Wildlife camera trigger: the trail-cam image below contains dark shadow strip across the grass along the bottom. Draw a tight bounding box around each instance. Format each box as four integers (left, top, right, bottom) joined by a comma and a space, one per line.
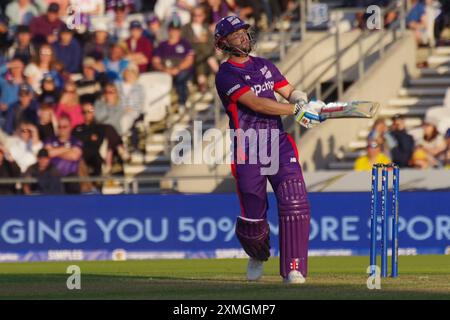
0, 274, 450, 300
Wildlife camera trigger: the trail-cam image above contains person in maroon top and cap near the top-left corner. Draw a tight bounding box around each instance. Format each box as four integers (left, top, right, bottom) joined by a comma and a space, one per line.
30, 2, 64, 44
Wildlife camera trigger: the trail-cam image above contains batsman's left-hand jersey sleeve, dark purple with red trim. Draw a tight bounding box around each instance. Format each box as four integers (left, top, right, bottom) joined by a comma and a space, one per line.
216, 69, 250, 103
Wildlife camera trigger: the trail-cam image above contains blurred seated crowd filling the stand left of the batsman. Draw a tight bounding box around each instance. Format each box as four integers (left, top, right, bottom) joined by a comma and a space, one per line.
0, 0, 294, 193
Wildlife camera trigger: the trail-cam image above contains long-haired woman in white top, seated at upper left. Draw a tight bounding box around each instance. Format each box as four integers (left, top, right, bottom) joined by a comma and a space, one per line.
24, 44, 62, 94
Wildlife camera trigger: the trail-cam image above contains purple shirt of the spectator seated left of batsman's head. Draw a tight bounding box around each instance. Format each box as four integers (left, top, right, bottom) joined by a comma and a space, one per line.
153, 39, 194, 68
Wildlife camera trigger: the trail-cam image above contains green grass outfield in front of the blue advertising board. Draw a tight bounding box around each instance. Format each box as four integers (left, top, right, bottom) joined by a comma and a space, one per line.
0, 255, 450, 299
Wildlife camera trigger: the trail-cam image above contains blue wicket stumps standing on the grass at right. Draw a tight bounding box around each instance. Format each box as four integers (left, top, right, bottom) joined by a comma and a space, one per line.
369, 163, 400, 278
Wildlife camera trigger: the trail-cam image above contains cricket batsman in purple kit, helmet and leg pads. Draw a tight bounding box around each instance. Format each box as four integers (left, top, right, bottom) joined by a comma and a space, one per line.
214, 16, 324, 284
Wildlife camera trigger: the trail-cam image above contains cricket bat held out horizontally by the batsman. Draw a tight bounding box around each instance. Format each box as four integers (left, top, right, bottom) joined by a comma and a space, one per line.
320, 101, 380, 121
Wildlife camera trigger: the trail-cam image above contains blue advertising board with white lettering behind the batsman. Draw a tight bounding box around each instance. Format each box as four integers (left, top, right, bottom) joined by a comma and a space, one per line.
0, 192, 450, 261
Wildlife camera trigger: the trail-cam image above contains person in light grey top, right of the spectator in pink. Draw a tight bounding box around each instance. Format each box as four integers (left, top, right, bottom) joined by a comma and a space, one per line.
95, 83, 126, 136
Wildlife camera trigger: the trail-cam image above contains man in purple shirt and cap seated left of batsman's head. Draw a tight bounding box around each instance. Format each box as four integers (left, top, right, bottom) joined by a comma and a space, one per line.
152, 19, 194, 113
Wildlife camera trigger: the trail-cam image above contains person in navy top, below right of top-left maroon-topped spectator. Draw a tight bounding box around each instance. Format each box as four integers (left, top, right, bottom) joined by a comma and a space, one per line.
53, 25, 82, 73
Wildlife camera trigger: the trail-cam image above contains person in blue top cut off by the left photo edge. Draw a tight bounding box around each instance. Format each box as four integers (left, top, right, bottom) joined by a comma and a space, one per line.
0, 58, 25, 127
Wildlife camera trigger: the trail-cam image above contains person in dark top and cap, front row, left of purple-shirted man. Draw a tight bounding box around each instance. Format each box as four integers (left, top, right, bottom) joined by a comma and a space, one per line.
23, 149, 64, 194
